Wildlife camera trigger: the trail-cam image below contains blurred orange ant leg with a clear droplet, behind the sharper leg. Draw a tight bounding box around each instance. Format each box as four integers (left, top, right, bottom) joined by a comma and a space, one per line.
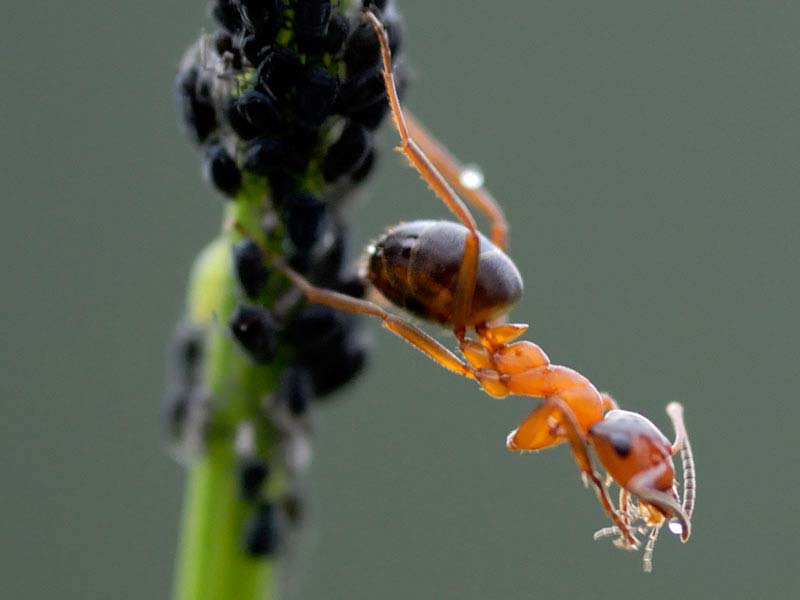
405, 109, 508, 250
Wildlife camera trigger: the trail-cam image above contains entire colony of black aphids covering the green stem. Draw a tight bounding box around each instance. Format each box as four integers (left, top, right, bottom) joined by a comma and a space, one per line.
165, 0, 403, 555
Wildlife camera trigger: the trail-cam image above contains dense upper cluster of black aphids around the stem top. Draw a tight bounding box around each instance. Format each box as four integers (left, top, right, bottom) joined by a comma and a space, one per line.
177, 0, 405, 201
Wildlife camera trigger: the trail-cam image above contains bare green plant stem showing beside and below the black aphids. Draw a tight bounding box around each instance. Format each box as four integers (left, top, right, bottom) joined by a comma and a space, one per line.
173, 187, 285, 600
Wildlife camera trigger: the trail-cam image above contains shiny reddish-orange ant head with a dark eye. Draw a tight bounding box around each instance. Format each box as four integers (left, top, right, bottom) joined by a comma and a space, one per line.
589, 409, 674, 492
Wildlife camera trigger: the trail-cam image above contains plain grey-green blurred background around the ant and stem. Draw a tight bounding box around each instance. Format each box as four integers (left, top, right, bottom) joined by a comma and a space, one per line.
0, 0, 800, 600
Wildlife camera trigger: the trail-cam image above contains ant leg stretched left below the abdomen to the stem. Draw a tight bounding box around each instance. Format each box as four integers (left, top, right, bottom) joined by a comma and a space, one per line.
272, 258, 475, 379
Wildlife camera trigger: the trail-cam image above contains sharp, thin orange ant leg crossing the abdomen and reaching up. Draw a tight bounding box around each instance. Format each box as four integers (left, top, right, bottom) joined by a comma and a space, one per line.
364, 10, 480, 340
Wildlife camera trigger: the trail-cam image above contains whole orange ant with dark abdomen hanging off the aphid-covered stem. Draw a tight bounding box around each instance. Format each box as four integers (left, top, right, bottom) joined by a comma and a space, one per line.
236, 10, 695, 571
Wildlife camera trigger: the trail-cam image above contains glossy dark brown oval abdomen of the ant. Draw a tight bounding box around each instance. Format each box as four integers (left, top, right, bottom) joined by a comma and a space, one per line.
366, 221, 522, 327
